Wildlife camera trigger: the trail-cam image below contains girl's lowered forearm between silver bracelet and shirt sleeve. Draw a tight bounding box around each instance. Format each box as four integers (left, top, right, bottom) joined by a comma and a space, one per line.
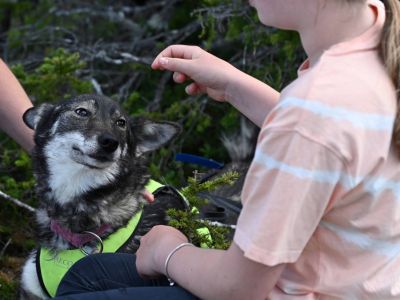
168, 243, 284, 300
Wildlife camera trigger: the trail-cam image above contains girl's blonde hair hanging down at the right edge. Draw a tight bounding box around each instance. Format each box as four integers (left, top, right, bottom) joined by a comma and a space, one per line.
380, 0, 400, 155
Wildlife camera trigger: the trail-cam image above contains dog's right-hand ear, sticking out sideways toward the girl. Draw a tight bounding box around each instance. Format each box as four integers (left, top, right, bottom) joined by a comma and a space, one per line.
132, 120, 181, 155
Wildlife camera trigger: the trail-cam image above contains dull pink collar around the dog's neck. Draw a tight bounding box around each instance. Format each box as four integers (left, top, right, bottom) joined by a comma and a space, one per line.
50, 220, 110, 248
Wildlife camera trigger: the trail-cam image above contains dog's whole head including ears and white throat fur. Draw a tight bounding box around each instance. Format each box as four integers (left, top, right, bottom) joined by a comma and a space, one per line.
23, 95, 180, 203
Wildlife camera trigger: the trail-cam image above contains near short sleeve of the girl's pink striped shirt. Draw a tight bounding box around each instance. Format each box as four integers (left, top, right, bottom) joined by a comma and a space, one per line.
234, 128, 345, 266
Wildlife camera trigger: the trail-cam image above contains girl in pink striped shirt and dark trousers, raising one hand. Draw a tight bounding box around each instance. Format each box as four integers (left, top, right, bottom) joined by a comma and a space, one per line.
54, 0, 400, 300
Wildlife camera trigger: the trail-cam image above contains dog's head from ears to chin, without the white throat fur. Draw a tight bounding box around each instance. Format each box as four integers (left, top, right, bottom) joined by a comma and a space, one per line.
23, 95, 180, 165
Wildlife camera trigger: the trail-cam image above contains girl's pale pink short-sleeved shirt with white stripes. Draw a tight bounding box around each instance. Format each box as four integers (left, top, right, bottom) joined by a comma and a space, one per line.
234, 0, 400, 300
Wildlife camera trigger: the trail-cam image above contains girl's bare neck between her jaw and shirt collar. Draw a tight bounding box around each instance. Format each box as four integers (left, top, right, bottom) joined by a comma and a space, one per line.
298, 1, 376, 66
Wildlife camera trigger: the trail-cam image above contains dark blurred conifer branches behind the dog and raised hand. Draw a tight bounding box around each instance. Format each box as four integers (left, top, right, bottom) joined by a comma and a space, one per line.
0, 0, 304, 299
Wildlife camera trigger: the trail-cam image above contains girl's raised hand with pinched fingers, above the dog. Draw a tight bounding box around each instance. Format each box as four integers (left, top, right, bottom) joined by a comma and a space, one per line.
151, 45, 238, 101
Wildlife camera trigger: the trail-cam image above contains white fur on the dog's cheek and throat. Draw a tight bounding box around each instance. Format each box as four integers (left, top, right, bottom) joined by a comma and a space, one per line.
44, 132, 121, 204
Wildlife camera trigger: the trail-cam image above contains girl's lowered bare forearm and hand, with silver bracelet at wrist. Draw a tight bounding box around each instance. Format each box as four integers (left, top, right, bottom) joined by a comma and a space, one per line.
136, 226, 285, 300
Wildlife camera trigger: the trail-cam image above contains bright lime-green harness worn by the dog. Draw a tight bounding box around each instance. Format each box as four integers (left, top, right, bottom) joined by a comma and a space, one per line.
36, 180, 163, 297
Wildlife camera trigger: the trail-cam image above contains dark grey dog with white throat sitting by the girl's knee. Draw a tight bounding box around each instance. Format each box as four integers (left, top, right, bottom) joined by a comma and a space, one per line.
21, 95, 186, 299
